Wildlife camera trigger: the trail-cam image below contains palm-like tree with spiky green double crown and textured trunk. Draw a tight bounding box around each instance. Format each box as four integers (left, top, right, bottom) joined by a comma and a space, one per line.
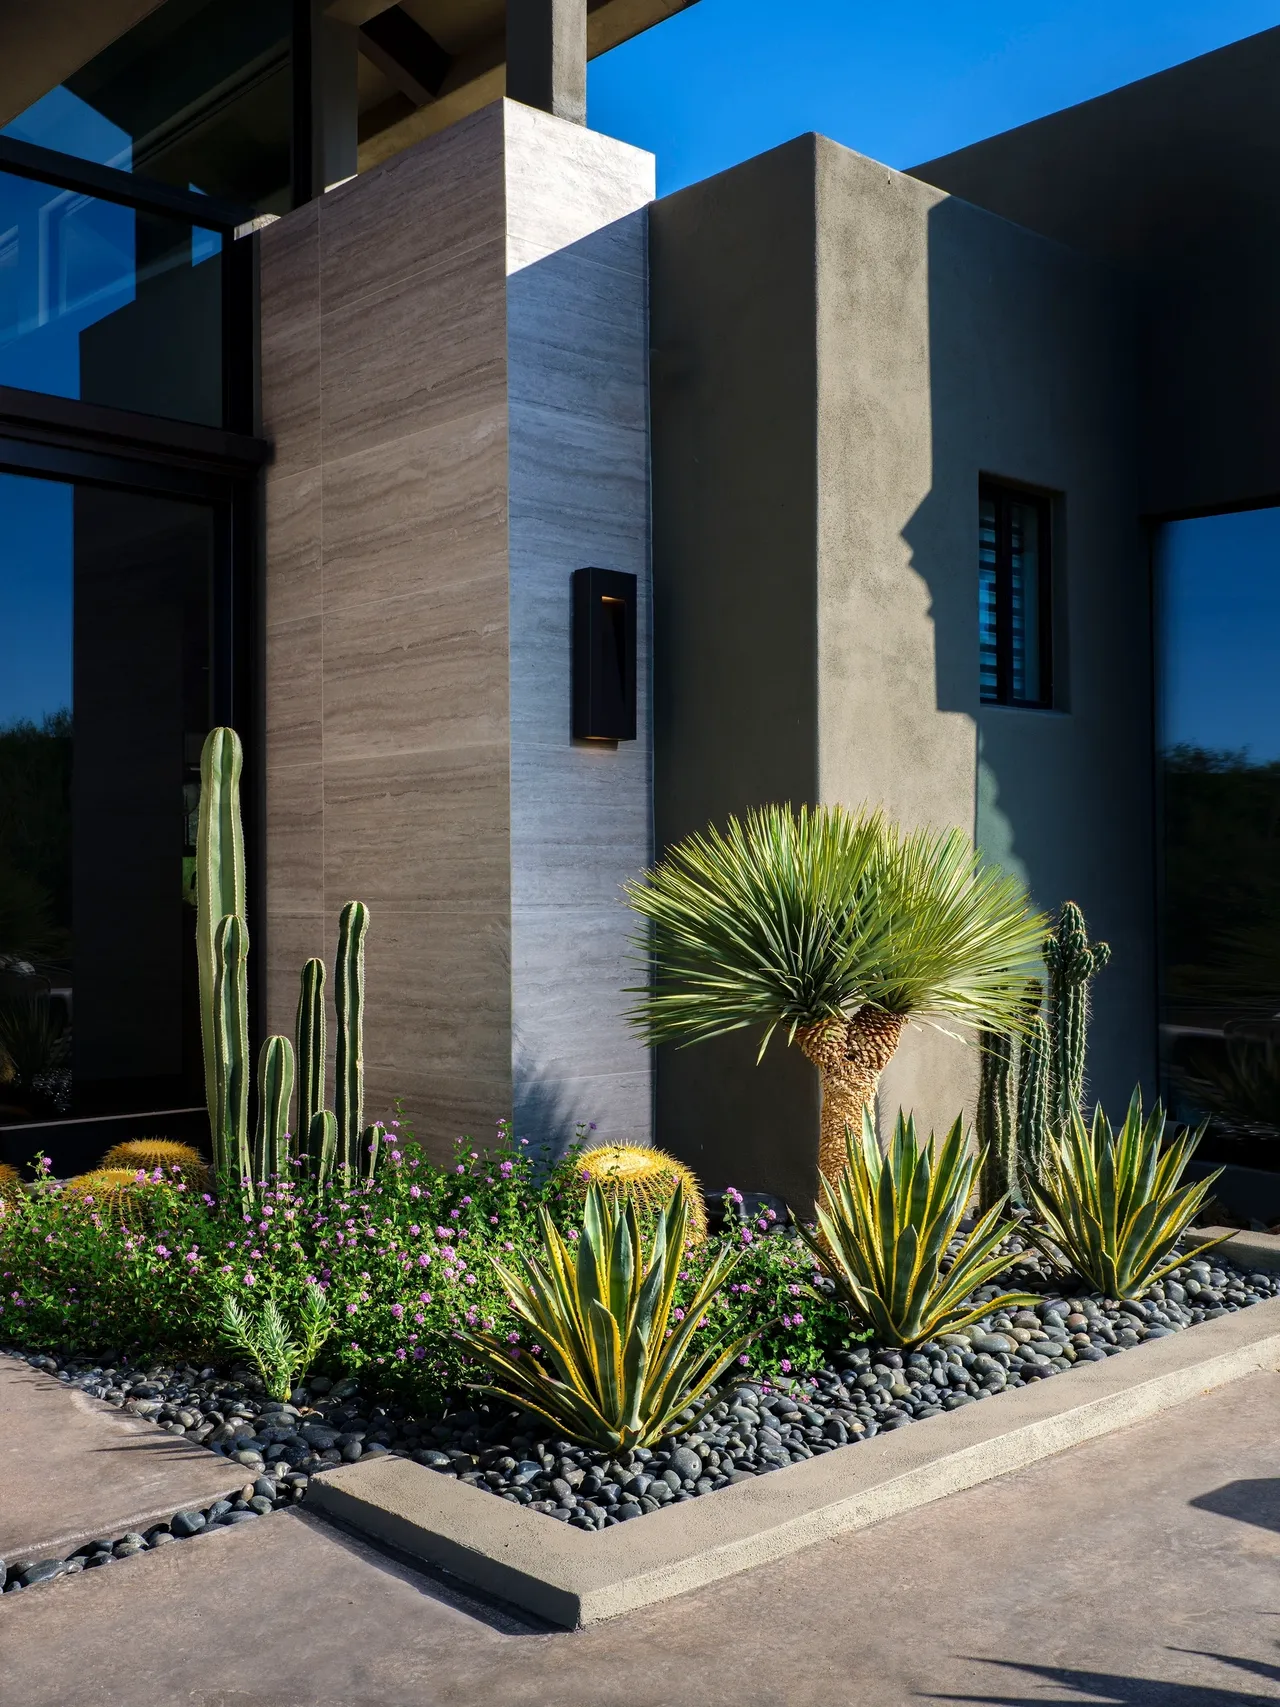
626, 806, 1046, 1180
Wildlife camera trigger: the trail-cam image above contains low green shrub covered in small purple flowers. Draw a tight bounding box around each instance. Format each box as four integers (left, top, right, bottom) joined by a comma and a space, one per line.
0, 1121, 863, 1410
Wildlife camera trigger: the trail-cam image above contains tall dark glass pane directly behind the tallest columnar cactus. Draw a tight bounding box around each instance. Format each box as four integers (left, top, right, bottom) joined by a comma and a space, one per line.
0, 475, 213, 1127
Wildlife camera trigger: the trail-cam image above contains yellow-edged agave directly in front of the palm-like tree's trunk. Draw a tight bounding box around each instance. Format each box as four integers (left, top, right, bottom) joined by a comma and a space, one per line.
800, 1111, 1034, 1345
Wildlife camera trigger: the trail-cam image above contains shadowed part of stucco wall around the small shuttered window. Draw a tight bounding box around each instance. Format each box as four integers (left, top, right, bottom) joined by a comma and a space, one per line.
903, 198, 1155, 1106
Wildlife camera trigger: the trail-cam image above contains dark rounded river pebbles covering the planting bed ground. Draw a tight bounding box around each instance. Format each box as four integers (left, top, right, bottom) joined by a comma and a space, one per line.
5, 1251, 1280, 1593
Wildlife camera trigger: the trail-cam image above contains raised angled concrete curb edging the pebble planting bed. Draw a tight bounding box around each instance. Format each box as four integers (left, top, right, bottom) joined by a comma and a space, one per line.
307, 1290, 1280, 1628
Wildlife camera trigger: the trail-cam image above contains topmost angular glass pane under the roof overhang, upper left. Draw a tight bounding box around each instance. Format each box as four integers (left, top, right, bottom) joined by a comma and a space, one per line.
3, 0, 292, 213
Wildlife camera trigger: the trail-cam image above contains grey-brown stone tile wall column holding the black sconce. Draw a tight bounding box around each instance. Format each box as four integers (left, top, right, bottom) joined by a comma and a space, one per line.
259, 102, 654, 1152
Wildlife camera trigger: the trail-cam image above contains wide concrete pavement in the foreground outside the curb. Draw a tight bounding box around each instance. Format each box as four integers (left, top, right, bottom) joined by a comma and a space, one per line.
0, 1374, 1280, 1707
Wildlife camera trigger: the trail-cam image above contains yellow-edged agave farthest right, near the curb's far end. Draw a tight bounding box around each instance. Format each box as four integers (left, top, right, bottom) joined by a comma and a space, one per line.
1026, 1091, 1225, 1299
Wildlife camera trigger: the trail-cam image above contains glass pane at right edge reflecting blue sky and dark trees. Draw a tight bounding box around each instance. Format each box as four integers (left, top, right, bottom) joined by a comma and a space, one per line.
1157, 509, 1280, 1166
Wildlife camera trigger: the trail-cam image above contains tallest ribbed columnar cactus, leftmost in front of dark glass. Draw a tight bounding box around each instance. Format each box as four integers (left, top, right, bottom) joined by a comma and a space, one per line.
196, 729, 244, 1168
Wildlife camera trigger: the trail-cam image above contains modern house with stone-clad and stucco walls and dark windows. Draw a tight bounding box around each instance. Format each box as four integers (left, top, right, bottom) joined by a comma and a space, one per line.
0, 0, 1280, 1200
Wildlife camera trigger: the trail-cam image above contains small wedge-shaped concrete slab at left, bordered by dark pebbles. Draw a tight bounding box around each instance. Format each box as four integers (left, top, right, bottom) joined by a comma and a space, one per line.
0, 1357, 244, 1562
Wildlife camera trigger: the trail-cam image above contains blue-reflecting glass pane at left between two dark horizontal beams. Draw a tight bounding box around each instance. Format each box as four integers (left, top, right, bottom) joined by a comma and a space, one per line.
0, 172, 222, 427
